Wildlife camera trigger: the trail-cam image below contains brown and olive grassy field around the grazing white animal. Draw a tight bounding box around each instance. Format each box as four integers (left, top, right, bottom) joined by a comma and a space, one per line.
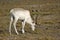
0, 0, 60, 40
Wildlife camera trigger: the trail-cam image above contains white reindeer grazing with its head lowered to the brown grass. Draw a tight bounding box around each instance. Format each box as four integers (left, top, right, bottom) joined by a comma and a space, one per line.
9, 8, 35, 34
